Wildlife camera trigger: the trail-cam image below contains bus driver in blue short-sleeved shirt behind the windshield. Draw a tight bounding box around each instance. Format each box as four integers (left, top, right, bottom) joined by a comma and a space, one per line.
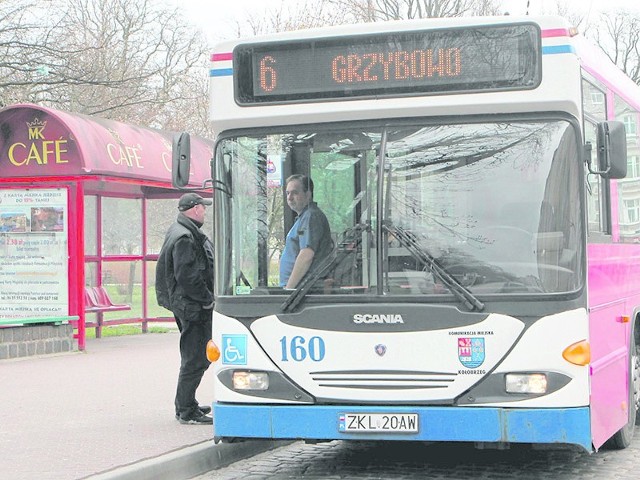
280, 174, 333, 289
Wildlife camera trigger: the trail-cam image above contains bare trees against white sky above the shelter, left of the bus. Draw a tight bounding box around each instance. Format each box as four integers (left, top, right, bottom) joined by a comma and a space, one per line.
0, 0, 211, 136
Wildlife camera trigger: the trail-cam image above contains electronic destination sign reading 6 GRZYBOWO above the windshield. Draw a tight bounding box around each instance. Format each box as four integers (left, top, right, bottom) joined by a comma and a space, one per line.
233, 23, 541, 105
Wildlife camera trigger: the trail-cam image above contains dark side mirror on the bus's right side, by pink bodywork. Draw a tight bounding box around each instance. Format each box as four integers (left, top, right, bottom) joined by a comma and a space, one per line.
589, 121, 627, 179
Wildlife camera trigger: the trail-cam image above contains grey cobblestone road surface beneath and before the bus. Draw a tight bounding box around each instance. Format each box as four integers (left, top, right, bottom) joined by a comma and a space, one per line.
197, 426, 640, 480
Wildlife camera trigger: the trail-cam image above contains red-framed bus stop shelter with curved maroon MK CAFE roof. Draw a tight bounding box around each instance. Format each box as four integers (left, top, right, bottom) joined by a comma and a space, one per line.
0, 104, 213, 350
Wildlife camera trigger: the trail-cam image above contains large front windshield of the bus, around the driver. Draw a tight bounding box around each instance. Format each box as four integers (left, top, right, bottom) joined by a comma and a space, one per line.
215, 119, 584, 301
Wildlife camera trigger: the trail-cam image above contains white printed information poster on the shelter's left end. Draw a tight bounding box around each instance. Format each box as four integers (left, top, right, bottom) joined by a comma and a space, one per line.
0, 189, 69, 319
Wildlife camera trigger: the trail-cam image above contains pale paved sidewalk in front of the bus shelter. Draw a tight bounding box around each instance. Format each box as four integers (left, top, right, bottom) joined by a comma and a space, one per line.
0, 332, 278, 480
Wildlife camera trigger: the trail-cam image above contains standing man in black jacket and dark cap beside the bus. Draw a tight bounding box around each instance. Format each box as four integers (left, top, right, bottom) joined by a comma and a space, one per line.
156, 193, 213, 425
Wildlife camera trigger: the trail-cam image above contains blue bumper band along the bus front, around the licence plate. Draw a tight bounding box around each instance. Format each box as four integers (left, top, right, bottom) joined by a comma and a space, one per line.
213, 404, 592, 452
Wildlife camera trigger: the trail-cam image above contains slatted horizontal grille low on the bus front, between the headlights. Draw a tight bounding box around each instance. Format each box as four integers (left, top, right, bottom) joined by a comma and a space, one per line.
310, 370, 457, 390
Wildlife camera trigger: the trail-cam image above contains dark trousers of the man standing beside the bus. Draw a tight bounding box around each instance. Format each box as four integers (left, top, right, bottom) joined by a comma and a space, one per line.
175, 310, 212, 419
